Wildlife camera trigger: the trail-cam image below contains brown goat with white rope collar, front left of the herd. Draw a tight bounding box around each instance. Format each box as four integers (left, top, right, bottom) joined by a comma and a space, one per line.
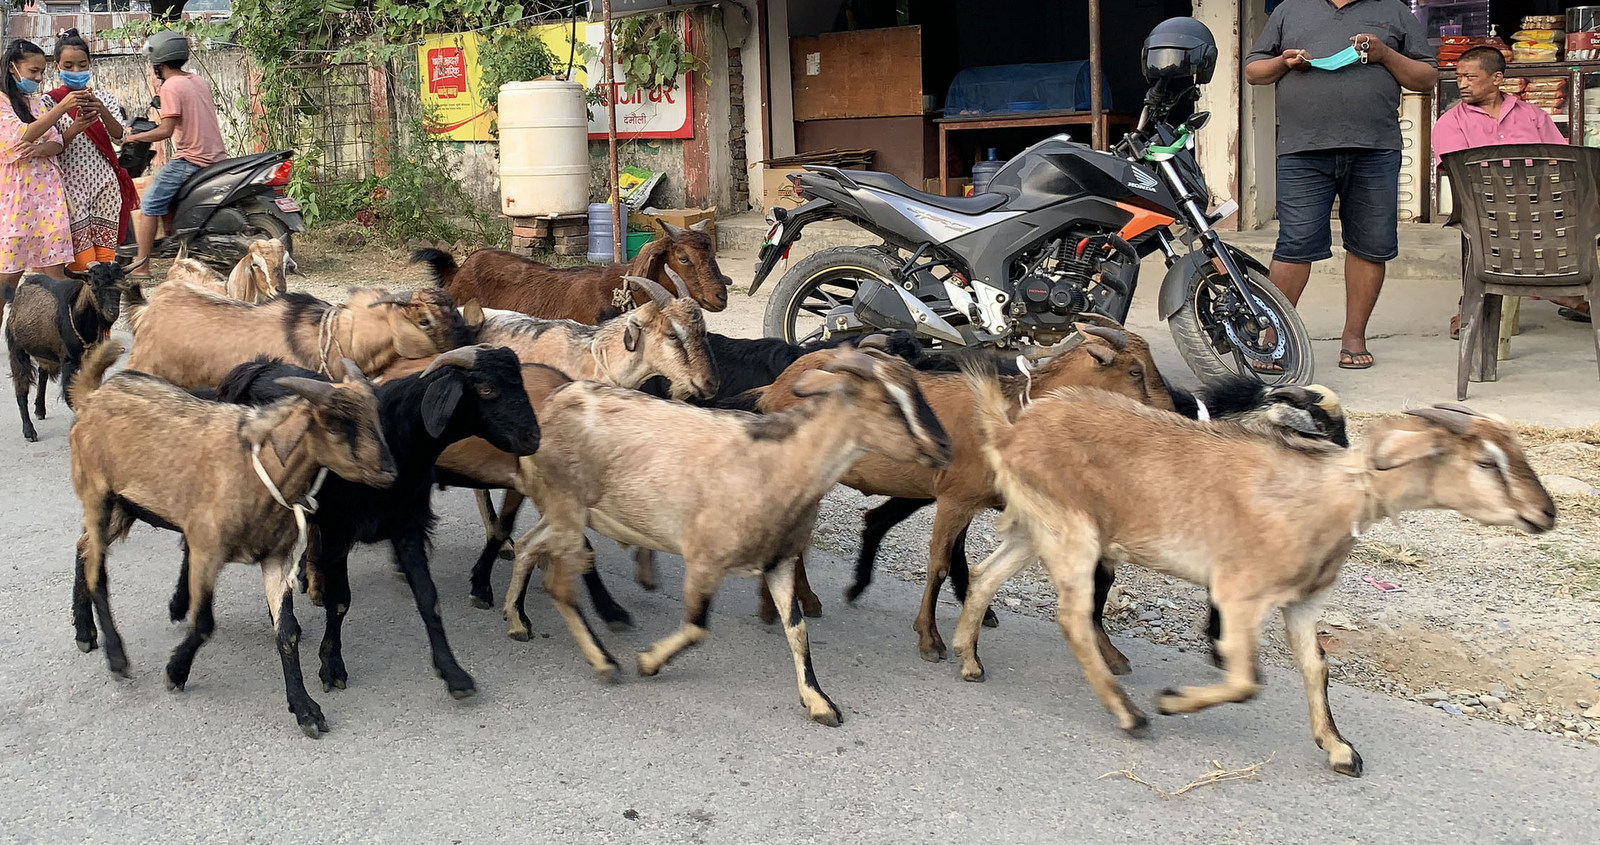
67, 341, 395, 738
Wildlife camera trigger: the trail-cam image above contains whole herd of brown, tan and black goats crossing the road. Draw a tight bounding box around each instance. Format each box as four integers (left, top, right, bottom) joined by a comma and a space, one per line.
0, 226, 1555, 775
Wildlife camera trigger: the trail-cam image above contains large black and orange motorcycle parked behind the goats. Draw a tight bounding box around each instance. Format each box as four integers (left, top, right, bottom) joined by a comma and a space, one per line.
750, 80, 1312, 384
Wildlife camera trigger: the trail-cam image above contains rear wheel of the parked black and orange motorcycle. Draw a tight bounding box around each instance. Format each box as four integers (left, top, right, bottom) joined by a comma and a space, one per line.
763, 246, 901, 344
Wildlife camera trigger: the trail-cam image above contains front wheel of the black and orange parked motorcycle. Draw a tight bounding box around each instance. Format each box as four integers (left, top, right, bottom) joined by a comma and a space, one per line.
1166, 256, 1315, 384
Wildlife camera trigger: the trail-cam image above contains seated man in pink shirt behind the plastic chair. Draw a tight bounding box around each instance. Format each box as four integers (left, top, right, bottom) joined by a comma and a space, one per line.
1434, 46, 1589, 331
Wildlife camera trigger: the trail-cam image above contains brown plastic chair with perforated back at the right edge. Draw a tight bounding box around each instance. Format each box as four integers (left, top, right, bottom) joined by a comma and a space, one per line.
1440, 144, 1600, 398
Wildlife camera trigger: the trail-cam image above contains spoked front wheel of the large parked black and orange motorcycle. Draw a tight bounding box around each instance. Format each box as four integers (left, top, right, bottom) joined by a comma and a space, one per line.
1166, 264, 1315, 384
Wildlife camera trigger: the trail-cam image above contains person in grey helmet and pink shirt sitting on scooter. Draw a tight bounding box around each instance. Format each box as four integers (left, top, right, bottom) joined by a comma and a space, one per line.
126, 32, 227, 277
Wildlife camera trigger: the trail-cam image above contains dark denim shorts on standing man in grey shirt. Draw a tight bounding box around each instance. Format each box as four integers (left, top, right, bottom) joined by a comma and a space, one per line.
1272, 149, 1400, 264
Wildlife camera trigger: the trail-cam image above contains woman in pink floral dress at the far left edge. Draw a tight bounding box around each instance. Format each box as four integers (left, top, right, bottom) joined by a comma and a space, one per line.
0, 38, 88, 326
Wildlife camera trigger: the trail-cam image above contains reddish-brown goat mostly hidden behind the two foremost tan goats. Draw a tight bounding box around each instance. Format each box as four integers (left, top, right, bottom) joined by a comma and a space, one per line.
757, 323, 1173, 661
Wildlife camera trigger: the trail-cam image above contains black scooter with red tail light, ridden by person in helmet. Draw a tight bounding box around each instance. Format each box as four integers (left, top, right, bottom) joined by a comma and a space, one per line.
118, 99, 306, 270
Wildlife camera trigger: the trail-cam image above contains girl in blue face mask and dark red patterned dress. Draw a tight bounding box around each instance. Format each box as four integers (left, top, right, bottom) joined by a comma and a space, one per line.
40, 29, 139, 272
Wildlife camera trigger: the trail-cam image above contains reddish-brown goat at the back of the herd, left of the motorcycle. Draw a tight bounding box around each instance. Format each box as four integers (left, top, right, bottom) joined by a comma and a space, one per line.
411, 221, 730, 325
